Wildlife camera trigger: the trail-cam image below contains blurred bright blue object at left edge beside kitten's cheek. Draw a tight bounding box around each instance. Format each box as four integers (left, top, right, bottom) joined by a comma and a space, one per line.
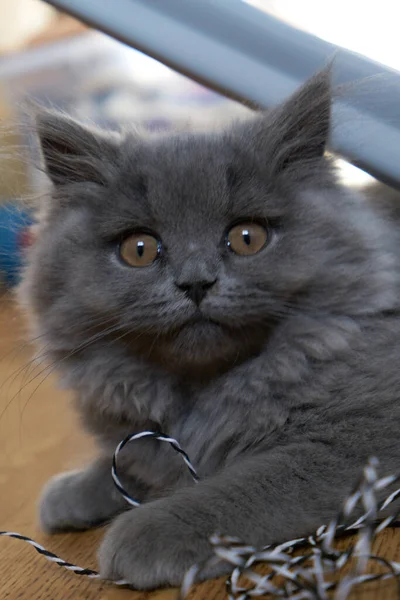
0, 202, 32, 287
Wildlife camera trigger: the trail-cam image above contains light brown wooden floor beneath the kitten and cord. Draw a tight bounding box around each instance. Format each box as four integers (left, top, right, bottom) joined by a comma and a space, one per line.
0, 300, 400, 600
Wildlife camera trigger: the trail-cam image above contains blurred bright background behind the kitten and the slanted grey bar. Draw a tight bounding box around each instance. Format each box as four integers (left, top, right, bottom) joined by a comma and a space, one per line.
0, 0, 400, 286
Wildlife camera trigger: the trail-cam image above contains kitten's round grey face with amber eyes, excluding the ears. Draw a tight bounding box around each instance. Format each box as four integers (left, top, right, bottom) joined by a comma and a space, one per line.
25, 132, 291, 364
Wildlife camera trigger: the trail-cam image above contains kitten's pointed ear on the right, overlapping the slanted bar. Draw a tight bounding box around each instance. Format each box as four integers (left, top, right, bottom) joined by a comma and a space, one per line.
265, 68, 332, 172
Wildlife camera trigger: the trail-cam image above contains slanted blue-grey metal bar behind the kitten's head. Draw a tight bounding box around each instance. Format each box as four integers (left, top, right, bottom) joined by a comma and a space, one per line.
47, 0, 400, 189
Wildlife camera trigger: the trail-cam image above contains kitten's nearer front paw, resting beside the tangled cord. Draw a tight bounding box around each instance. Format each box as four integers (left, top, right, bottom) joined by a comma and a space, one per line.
99, 501, 216, 589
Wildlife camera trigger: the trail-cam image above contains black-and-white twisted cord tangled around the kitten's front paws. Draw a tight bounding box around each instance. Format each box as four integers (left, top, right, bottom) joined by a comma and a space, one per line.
0, 431, 400, 600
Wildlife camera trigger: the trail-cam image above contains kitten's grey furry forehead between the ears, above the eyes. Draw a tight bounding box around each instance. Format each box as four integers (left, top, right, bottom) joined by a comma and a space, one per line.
90, 133, 269, 243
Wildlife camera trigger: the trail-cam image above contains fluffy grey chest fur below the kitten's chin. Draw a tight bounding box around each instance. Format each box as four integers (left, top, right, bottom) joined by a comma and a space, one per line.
73, 344, 287, 488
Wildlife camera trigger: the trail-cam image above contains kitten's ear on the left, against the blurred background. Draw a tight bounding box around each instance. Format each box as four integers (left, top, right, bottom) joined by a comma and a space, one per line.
36, 111, 117, 186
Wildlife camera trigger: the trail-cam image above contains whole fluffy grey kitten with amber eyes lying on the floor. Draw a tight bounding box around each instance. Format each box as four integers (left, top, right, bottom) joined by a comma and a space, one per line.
21, 72, 400, 588
